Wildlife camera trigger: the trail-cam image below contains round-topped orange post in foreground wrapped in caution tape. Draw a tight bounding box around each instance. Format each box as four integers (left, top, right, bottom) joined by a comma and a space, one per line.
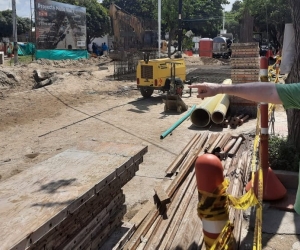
195, 154, 229, 249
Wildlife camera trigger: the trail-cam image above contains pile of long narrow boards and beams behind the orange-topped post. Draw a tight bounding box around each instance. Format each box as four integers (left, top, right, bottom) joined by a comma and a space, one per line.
108, 132, 252, 250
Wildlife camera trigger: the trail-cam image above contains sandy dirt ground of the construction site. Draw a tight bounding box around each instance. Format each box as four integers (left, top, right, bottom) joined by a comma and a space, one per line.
0, 57, 299, 249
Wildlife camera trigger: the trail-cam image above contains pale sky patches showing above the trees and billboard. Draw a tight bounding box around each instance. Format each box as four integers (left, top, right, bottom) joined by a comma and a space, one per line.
0, 0, 235, 18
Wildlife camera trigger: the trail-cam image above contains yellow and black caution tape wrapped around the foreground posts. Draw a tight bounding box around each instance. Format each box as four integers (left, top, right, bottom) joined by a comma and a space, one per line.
197, 100, 275, 250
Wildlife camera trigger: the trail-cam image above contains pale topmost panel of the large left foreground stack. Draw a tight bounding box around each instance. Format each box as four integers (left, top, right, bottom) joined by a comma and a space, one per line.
0, 146, 144, 249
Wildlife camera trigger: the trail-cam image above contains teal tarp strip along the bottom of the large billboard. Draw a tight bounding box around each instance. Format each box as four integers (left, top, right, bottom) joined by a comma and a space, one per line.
35, 49, 88, 60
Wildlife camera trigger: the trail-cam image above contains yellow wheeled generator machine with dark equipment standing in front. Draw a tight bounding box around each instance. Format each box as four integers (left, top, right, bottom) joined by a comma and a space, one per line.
136, 54, 191, 112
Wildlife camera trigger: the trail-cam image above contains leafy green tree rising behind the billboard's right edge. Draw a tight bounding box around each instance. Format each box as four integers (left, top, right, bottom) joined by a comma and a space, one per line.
60, 0, 111, 44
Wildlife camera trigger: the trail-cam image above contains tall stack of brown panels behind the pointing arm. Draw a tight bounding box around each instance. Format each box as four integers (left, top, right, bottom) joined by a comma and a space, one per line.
230, 43, 260, 116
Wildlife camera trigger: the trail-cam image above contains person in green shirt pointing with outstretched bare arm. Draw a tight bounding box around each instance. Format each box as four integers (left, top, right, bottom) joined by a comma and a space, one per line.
188, 82, 300, 214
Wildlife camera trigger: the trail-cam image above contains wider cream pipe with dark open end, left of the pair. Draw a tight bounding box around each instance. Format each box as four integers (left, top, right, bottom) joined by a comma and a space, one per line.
191, 94, 223, 128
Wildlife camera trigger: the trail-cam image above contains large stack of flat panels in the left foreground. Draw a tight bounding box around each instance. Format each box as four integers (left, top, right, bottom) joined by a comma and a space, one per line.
0, 142, 147, 250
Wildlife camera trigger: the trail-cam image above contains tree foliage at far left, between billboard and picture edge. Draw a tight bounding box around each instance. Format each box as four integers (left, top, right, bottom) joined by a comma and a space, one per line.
0, 10, 30, 37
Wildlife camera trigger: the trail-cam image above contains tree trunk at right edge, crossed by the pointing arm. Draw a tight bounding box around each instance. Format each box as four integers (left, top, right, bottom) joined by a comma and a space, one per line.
286, 0, 300, 151
